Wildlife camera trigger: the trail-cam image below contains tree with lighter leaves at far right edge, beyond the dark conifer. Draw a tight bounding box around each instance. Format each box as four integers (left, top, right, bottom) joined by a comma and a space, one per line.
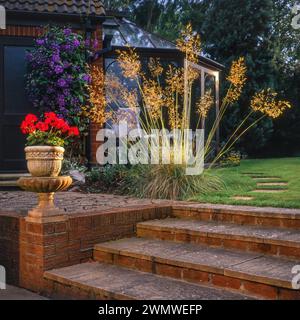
268, 0, 300, 155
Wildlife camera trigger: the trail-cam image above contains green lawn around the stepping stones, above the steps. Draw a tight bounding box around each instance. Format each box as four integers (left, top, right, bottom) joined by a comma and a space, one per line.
190, 158, 300, 208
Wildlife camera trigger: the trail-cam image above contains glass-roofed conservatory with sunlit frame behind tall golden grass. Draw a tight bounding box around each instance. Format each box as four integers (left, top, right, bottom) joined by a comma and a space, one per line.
95, 17, 224, 145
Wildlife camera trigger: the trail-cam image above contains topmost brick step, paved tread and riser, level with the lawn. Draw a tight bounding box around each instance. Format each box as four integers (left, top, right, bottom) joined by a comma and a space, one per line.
172, 203, 300, 230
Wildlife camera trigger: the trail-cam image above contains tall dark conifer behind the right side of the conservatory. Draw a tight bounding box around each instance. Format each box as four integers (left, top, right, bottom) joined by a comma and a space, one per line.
193, 0, 273, 154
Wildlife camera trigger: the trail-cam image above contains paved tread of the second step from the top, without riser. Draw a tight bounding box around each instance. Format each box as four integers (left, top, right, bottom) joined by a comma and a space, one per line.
138, 218, 300, 248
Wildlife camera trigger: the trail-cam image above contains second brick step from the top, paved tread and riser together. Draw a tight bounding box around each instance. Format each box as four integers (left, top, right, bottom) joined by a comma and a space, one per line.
137, 218, 300, 260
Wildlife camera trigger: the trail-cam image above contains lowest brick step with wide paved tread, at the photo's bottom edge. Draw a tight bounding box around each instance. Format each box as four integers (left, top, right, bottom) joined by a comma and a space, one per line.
44, 262, 253, 300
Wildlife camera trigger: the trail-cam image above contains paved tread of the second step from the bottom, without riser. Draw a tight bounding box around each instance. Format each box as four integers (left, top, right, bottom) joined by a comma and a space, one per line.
95, 238, 300, 289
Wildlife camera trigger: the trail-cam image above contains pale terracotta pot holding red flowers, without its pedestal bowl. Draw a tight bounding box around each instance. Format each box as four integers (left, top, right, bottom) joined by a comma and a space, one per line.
25, 146, 65, 177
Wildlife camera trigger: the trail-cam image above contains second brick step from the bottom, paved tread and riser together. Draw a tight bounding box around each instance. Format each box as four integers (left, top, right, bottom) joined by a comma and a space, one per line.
94, 238, 300, 299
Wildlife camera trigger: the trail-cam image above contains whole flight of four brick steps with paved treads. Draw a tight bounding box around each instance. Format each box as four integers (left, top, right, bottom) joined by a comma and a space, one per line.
44, 204, 300, 300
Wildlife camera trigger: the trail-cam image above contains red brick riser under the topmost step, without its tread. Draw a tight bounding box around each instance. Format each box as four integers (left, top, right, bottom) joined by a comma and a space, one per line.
172, 208, 300, 230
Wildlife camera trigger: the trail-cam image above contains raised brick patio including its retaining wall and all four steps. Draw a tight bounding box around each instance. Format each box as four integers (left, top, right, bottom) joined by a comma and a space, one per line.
0, 192, 300, 299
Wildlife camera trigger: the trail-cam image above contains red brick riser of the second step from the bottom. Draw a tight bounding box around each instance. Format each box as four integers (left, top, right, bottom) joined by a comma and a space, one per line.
94, 248, 300, 300
